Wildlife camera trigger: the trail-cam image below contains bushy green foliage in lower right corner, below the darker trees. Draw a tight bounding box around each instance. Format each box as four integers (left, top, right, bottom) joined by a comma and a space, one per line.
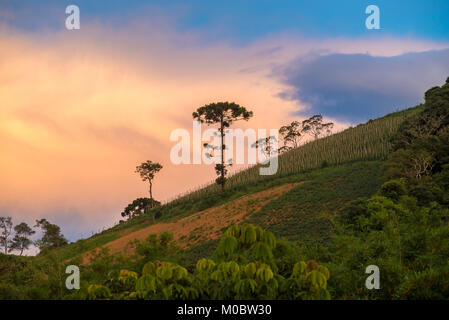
327, 196, 449, 299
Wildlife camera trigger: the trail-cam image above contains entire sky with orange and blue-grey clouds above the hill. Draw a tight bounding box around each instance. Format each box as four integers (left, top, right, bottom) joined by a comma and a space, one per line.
0, 0, 449, 251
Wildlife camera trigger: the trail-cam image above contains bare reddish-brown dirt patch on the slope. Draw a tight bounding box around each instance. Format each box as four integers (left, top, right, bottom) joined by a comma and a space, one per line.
83, 181, 305, 263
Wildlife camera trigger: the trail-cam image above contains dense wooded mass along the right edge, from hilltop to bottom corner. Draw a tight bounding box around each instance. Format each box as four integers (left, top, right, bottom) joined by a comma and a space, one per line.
309, 78, 449, 299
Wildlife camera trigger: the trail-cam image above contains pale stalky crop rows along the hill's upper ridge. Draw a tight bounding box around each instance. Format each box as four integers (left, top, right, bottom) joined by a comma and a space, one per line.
161, 107, 421, 208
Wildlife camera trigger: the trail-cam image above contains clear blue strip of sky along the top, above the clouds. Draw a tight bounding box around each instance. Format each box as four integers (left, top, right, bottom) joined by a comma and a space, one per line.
0, 0, 449, 43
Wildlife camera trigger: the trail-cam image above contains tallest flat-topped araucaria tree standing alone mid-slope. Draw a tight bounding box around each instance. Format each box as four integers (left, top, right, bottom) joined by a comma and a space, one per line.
192, 102, 253, 191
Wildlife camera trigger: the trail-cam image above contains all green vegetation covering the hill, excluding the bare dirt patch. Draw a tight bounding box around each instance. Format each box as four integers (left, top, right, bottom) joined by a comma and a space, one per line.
0, 79, 449, 299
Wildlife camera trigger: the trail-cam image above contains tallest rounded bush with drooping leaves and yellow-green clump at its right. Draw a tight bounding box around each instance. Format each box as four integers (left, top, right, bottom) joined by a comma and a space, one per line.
191, 225, 330, 299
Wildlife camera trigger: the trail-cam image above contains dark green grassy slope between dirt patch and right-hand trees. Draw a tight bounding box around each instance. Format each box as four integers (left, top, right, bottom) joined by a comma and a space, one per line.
247, 161, 381, 244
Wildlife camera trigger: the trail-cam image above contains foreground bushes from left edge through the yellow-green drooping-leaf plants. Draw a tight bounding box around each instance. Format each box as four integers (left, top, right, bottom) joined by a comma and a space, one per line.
0, 225, 330, 300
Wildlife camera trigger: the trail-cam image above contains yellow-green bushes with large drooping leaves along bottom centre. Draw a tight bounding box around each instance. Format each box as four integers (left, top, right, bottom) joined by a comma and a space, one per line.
88, 225, 330, 300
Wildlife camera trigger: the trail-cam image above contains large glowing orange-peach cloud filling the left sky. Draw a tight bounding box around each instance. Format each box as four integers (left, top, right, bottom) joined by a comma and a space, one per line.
0, 23, 300, 235
